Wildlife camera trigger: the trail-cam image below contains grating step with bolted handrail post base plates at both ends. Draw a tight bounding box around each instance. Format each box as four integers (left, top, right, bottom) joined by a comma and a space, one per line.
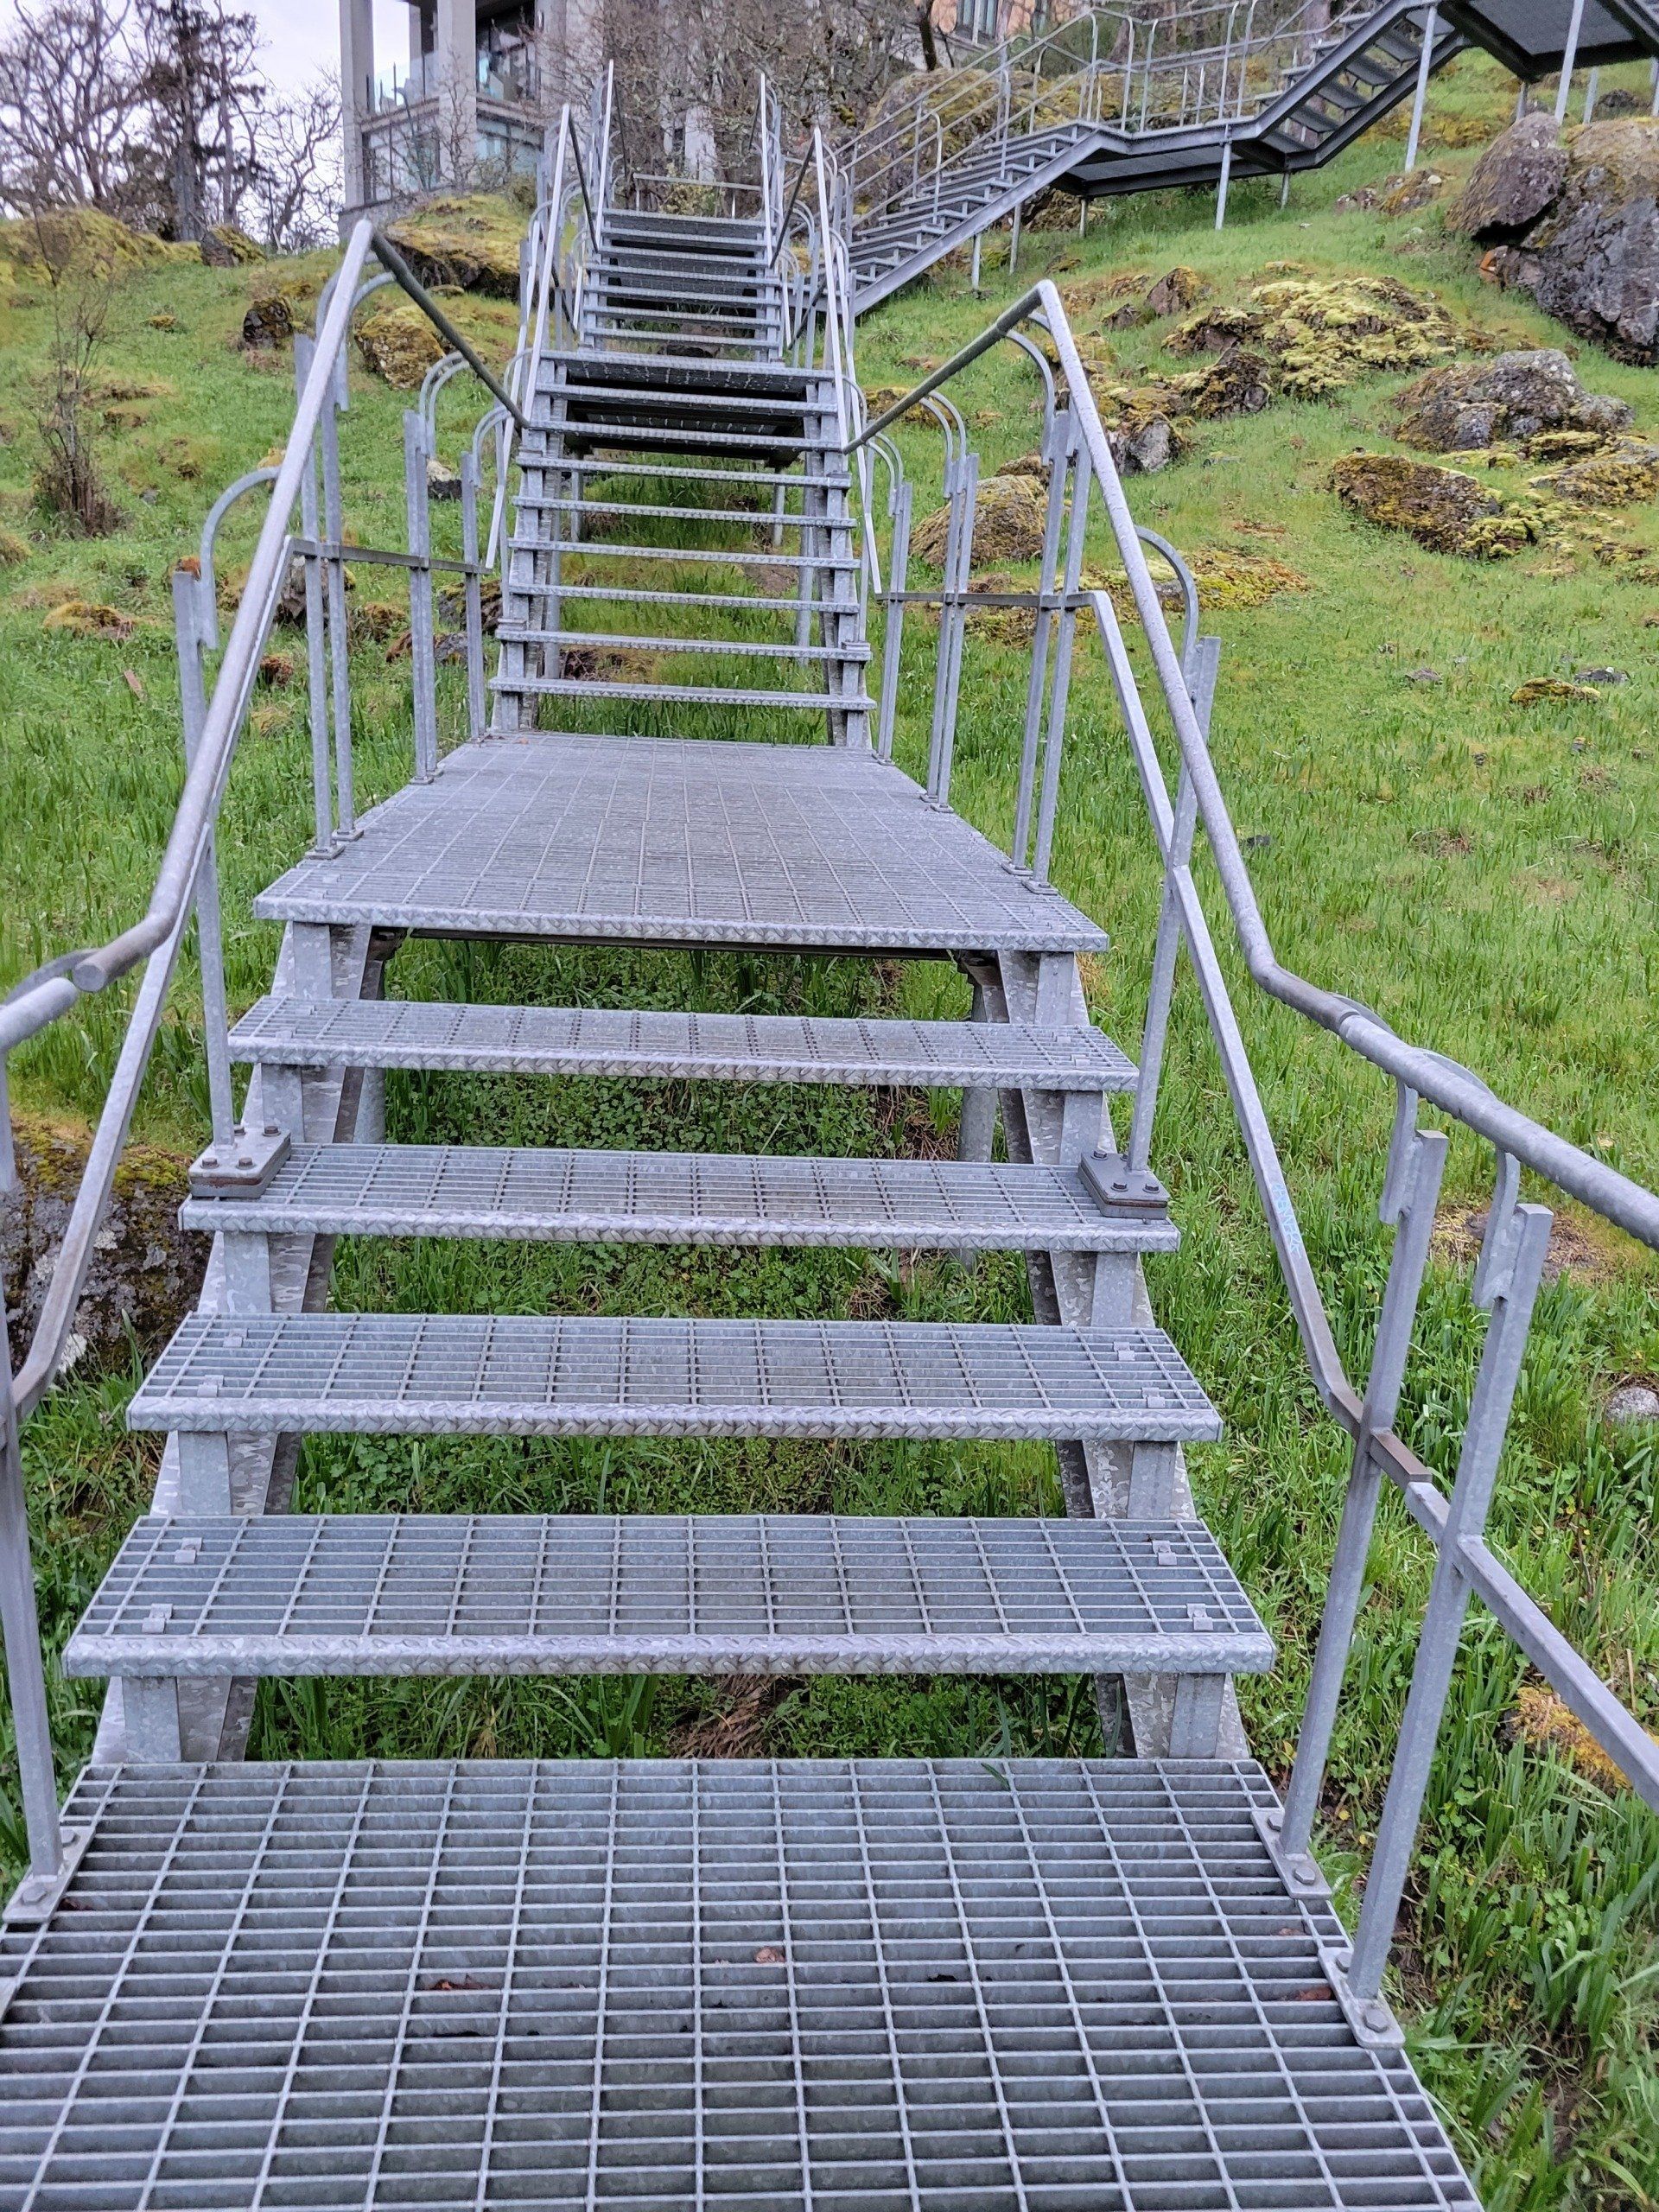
179, 1144, 1179, 1252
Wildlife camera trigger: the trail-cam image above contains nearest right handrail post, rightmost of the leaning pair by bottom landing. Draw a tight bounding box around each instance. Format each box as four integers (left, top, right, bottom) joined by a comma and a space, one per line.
1347, 1203, 1551, 2024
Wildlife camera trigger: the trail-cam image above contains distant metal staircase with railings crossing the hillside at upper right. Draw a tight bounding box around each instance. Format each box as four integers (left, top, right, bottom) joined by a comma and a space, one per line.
838, 0, 1659, 315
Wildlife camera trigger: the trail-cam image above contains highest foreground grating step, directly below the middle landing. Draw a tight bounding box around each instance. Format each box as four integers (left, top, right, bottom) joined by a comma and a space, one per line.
230, 998, 1135, 1093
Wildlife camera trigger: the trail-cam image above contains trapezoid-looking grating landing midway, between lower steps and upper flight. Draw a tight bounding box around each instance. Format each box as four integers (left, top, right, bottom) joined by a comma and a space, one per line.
254, 732, 1106, 951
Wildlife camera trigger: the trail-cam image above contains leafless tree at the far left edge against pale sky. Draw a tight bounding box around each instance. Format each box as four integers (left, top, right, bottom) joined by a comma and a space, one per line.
0, 0, 146, 214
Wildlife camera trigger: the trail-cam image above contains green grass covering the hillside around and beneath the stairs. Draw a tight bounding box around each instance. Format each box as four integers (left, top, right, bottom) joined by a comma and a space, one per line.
0, 60, 1659, 2212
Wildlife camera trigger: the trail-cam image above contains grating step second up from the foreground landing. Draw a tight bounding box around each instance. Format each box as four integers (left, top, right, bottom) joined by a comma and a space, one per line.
128, 1314, 1221, 1445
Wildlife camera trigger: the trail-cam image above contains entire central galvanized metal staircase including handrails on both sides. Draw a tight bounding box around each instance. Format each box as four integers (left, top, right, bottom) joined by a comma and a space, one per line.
0, 69, 1659, 2212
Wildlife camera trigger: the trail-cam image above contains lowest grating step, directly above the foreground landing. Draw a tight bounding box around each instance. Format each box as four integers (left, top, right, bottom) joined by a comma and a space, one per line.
64, 1513, 1274, 1676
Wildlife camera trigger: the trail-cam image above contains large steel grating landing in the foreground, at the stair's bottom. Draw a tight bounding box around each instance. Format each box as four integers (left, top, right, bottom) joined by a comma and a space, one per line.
0, 1758, 1478, 2212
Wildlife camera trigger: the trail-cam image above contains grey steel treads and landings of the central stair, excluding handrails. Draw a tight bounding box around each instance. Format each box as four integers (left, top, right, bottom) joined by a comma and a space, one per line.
0, 199, 1476, 2212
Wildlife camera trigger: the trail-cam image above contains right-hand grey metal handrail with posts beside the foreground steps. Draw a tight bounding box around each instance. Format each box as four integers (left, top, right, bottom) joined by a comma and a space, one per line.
847, 281, 1659, 2008
